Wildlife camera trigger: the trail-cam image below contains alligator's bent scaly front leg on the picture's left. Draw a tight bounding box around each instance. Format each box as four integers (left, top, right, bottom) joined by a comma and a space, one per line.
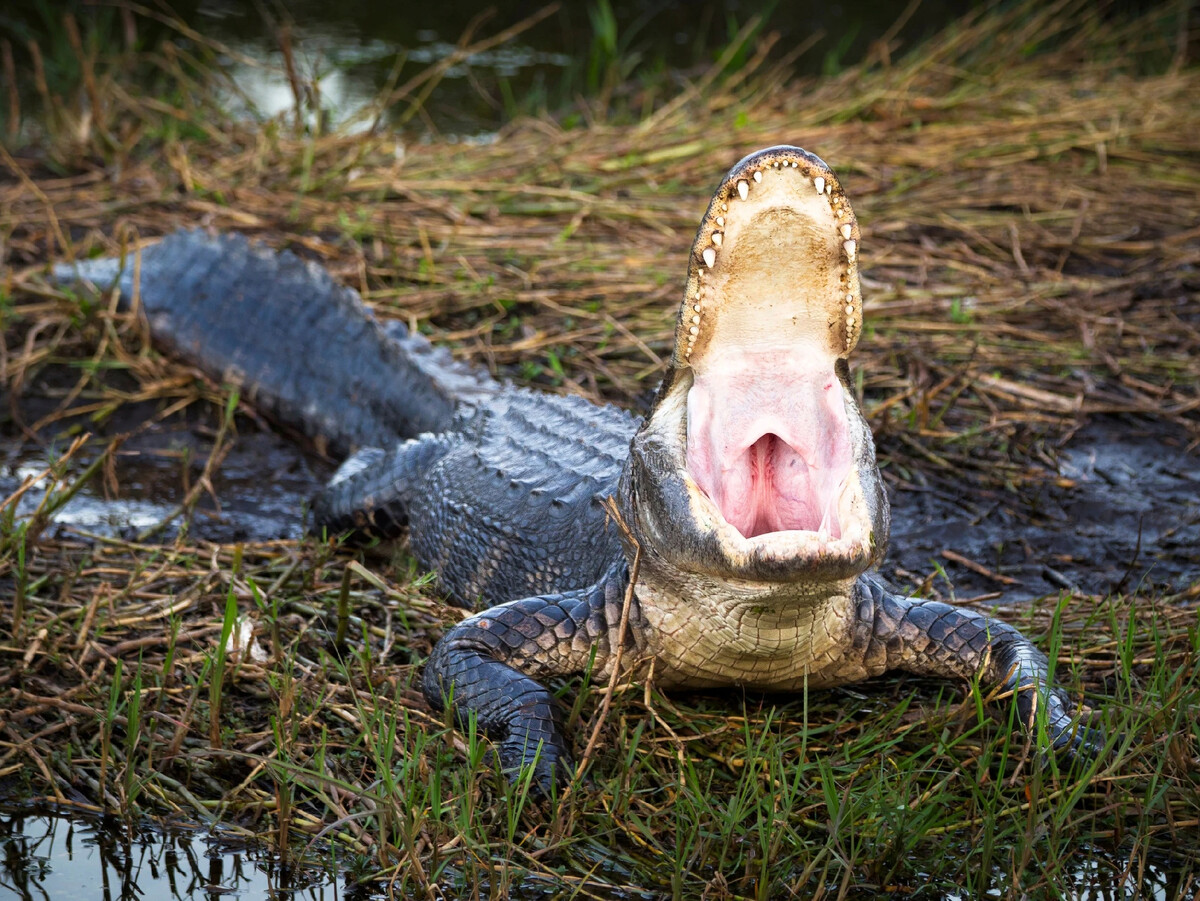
424, 564, 636, 793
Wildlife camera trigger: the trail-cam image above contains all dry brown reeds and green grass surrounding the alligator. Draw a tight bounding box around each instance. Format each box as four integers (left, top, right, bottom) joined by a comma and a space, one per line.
0, 2, 1200, 897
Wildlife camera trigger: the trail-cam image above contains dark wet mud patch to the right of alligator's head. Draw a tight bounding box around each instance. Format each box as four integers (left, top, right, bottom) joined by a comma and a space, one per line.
884, 418, 1200, 601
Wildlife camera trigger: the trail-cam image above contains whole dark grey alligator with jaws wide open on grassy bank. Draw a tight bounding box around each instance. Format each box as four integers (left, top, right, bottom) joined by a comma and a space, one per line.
58, 146, 1103, 791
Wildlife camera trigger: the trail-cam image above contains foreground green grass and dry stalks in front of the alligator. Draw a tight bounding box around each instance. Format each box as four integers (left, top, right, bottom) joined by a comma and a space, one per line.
0, 508, 1200, 899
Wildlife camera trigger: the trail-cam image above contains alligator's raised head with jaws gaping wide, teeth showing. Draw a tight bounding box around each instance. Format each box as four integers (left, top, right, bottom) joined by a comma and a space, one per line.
623, 146, 888, 593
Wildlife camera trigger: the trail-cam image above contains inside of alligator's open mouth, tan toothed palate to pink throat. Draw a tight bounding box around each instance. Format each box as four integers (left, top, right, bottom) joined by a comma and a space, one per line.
680, 152, 863, 545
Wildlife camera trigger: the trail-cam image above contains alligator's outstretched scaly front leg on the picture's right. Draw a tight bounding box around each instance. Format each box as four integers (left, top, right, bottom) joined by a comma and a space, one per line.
853, 578, 1103, 755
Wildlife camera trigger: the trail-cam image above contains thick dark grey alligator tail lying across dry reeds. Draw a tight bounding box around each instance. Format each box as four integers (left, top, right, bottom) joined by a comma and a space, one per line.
54, 232, 499, 456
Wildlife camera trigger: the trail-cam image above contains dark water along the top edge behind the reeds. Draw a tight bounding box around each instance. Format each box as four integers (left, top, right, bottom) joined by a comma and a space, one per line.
0, 0, 1153, 140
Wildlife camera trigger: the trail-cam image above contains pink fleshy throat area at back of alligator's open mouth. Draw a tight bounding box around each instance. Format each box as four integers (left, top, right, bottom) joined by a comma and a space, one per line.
688, 352, 851, 537
